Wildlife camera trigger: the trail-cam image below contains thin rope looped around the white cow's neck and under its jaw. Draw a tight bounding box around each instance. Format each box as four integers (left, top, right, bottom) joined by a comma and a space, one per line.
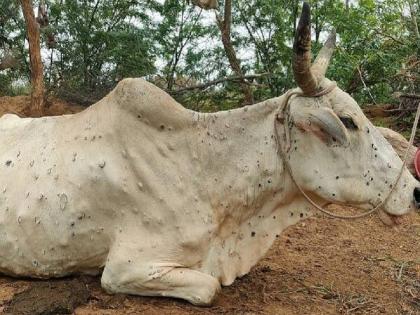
274, 82, 420, 219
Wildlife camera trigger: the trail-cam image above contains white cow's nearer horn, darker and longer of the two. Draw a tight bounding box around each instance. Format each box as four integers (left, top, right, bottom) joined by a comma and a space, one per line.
293, 2, 318, 95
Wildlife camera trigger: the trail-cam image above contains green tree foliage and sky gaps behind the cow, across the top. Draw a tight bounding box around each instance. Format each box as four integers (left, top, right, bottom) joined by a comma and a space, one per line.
0, 0, 420, 111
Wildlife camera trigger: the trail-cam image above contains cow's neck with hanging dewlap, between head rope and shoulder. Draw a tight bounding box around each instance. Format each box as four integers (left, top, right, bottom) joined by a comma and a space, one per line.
192, 98, 316, 285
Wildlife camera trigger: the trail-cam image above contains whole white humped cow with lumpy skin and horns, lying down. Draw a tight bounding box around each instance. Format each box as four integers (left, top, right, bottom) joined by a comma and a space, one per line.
0, 4, 420, 305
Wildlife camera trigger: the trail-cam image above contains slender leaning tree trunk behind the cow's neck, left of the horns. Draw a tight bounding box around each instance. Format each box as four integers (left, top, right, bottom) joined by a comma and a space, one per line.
216, 0, 254, 105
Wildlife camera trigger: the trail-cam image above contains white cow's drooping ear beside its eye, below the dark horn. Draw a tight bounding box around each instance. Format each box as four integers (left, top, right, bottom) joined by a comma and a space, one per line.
295, 107, 349, 146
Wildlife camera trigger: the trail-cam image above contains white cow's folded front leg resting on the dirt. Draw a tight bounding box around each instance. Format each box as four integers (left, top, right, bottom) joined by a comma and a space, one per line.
101, 247, 220, 306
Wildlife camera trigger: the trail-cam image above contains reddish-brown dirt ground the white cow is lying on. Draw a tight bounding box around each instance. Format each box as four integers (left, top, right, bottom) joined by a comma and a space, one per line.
0, 98, 420, 315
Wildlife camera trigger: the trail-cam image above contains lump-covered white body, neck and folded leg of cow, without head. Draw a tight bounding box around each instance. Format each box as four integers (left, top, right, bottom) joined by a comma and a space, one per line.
0, 79, 414, 305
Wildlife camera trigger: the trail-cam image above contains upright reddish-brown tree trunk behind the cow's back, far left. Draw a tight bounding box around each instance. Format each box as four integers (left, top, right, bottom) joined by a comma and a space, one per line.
20, 0, 44, 116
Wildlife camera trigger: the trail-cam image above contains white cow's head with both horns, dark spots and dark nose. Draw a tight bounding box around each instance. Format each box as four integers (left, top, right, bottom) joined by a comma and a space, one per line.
277, 3, 420, 225
